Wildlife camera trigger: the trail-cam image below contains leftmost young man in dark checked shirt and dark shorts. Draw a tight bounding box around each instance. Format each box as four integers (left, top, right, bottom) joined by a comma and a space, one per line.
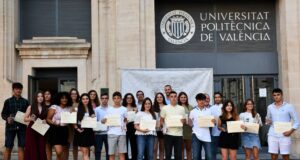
1, 82, 29, 160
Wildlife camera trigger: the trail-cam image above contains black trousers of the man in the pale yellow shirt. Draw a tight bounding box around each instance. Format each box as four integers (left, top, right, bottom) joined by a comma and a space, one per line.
164, 135, 183, 160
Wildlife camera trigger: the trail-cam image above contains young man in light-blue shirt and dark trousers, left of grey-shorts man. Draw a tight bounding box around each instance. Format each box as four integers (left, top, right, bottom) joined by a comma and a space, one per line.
95, 93, 111, 160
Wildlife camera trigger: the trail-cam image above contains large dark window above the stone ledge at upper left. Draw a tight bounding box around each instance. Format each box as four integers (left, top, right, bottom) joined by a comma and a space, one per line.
20, 0, 91, 41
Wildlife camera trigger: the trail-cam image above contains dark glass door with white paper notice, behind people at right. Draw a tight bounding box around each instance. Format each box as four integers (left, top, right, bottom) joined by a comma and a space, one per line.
214, 75, 278, 146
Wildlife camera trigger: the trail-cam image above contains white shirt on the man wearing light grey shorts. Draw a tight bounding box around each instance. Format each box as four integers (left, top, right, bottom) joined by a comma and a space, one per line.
106, 106, 127, 135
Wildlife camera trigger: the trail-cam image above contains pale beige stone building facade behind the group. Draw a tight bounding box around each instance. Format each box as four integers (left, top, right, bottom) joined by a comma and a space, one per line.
0, 0, 300, 158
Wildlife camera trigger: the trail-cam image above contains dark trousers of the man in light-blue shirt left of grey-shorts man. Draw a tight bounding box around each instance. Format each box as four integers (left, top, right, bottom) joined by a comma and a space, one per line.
95, 134, 109, 160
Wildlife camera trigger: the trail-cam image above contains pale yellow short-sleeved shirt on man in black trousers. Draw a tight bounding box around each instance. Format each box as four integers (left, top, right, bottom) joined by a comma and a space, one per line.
160, 104, 185, 136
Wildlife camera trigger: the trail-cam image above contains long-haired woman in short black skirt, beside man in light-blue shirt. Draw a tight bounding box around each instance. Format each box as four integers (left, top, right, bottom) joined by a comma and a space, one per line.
74, 93, 95, 160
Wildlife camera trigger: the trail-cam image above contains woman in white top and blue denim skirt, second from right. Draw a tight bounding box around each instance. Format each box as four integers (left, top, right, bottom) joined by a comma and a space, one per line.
240, 99, 262, 160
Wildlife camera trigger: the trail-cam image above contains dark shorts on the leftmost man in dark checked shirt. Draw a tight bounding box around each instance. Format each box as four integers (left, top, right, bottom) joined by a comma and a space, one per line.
5, 129, 26, 149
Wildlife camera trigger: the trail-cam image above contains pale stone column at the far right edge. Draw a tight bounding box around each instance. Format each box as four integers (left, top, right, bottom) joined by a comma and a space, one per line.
276, 0, 300, 159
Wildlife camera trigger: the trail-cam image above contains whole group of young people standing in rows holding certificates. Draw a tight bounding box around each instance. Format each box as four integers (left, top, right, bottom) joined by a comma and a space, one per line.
1, 83, 299, 160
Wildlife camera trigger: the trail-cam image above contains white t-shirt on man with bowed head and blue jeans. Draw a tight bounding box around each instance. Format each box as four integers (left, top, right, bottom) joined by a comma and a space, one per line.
189, 107, 212, 142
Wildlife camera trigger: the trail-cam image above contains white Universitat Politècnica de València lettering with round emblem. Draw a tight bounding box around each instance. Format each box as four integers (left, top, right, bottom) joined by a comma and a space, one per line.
160, 10, 271, 45
